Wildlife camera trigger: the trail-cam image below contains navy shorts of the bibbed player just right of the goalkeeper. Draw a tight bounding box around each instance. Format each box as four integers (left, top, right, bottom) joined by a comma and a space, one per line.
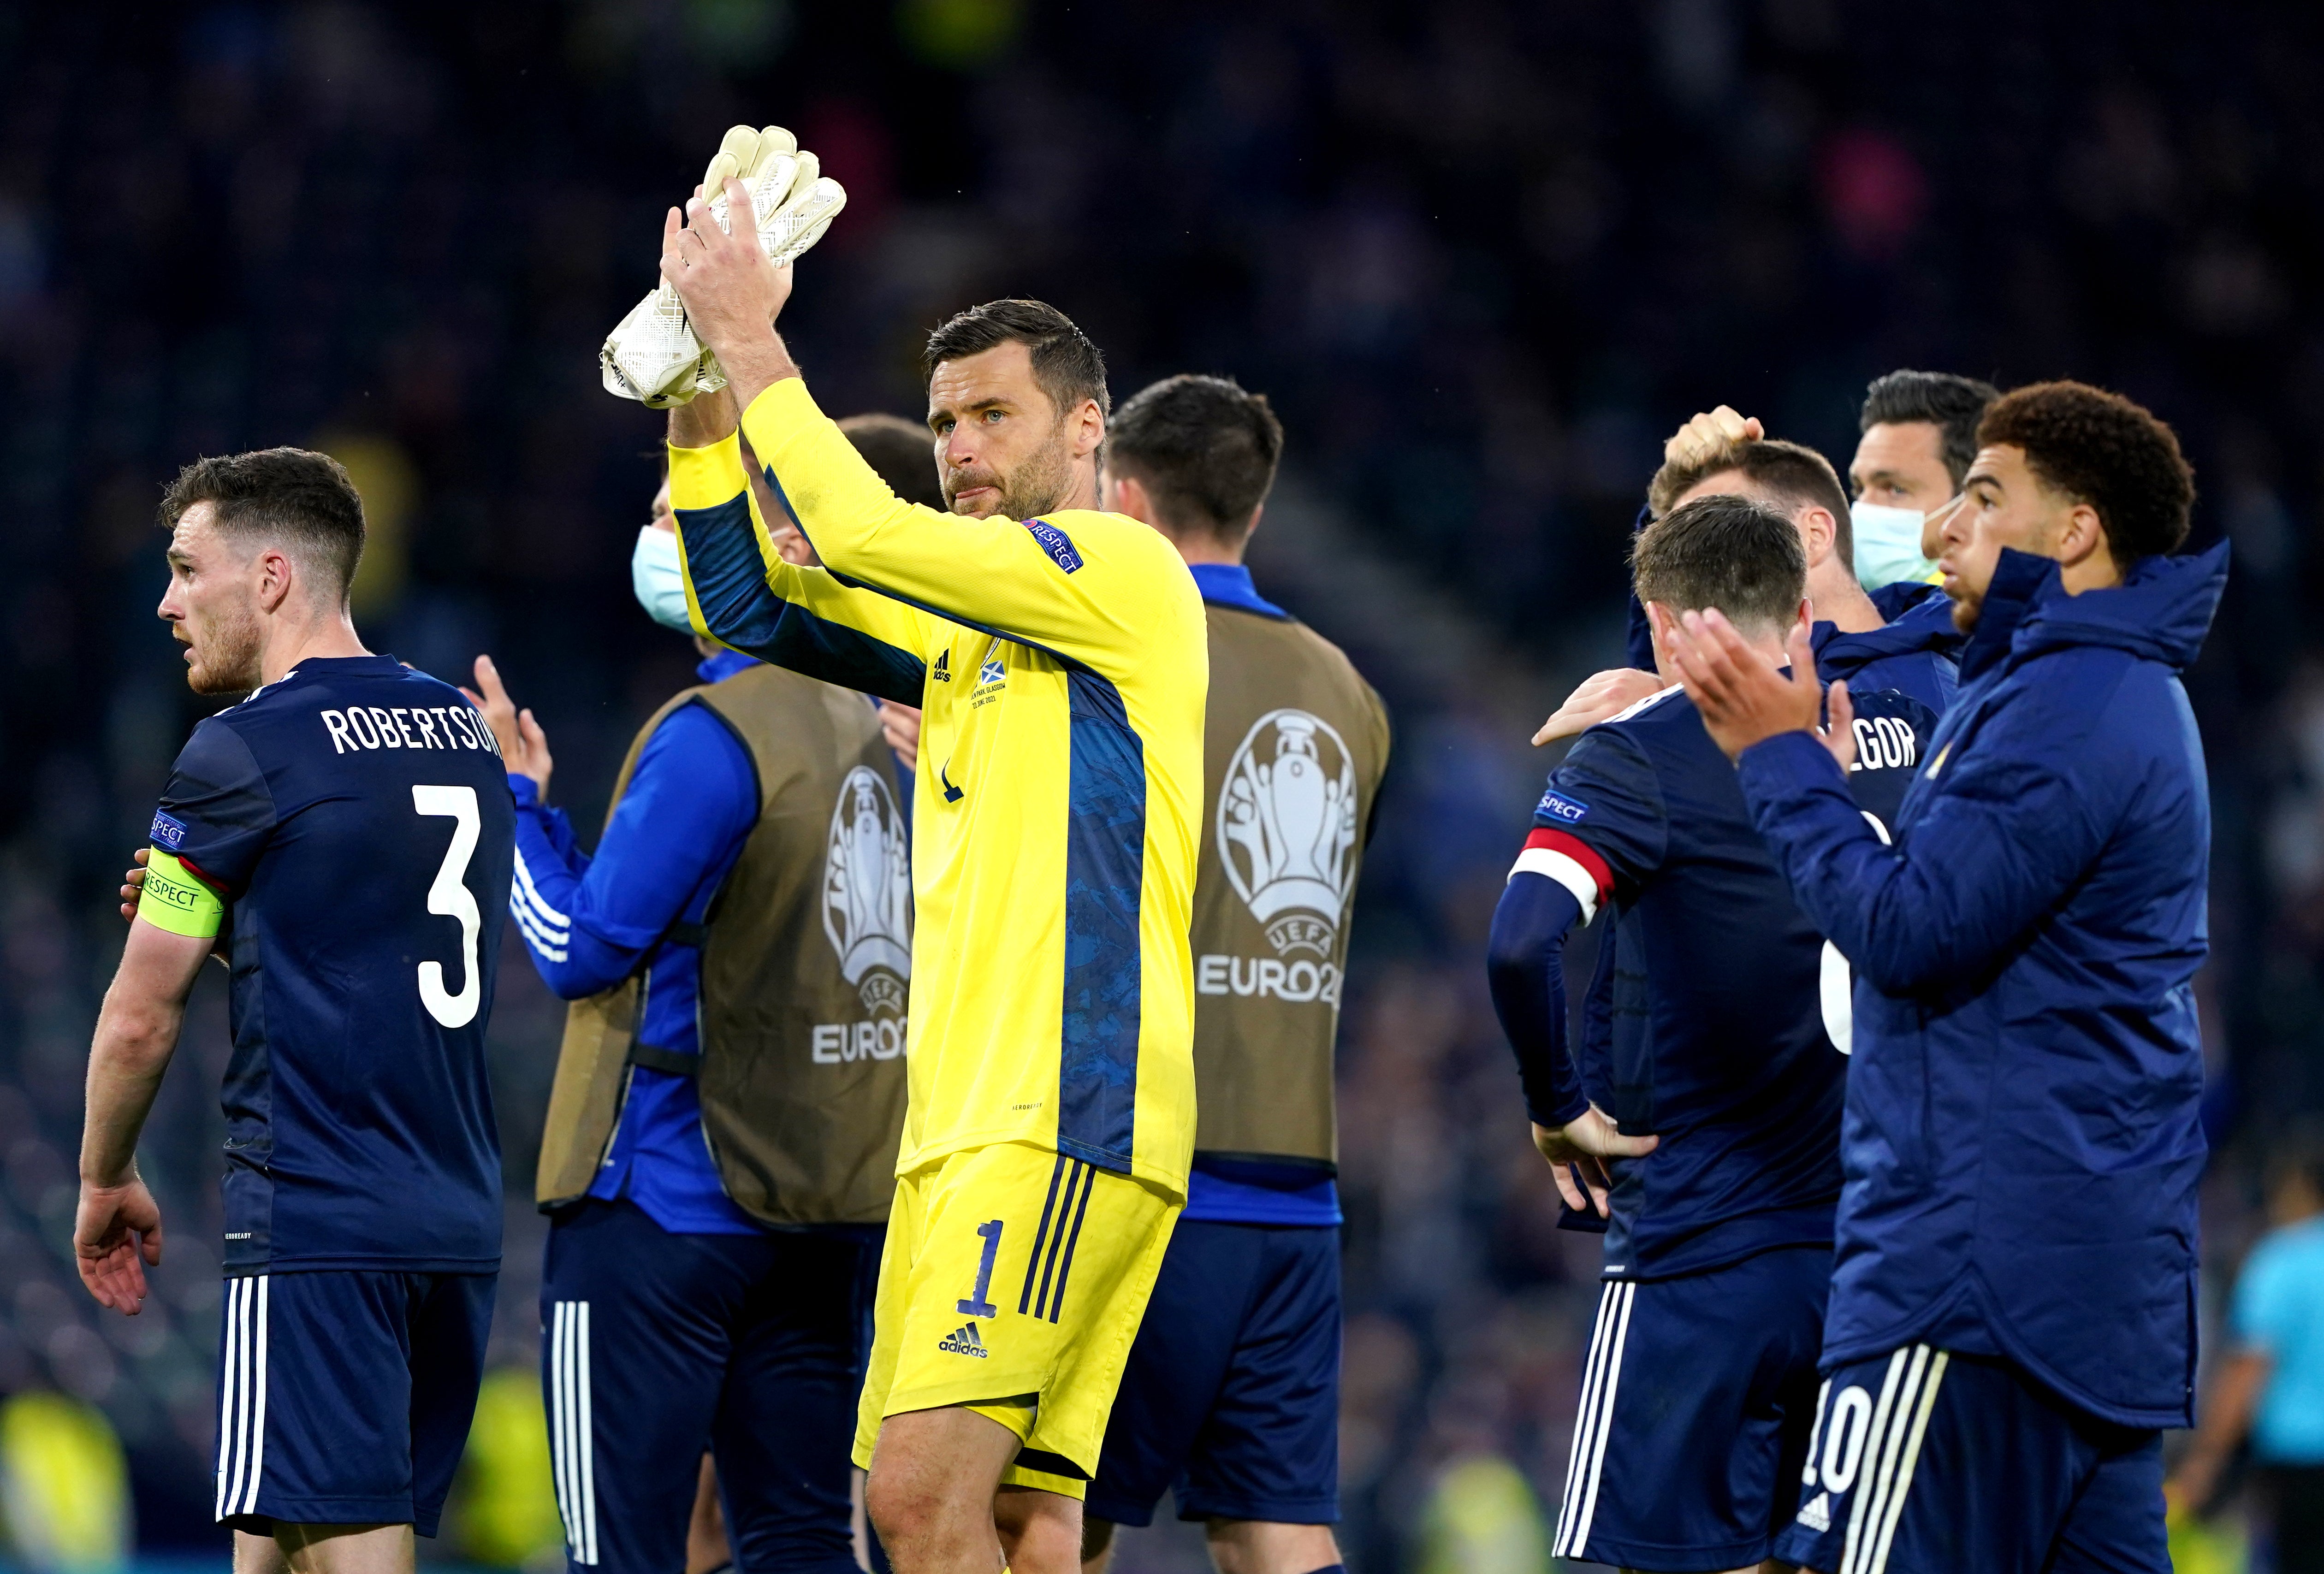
1083, 1218, 1339, 1525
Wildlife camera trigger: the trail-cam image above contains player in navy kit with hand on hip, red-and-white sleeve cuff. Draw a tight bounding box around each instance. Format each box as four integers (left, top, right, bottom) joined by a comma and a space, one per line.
1490, 491, 1922, 1569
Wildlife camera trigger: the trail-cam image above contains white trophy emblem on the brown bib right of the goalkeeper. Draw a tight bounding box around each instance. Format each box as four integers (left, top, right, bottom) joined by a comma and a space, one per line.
1218, 709, 1357, 967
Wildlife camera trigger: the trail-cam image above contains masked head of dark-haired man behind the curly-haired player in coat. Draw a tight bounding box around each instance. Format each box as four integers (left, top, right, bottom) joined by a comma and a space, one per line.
1848, 372, 2001, 591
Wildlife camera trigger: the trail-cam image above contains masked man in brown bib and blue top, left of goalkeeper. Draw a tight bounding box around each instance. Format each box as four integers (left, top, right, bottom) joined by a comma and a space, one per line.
476, 416, 937, 1574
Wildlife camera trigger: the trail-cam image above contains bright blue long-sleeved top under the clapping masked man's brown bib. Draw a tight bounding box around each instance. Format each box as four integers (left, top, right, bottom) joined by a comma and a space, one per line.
509, 651, 760, 1235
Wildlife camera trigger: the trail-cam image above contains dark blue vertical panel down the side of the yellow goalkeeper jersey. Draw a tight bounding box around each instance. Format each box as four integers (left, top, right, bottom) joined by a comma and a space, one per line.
1057, 669, 1146, 1174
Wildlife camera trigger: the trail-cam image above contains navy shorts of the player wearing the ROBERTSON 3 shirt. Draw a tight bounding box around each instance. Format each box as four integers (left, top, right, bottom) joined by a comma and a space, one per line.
216, 1269, 500, 1537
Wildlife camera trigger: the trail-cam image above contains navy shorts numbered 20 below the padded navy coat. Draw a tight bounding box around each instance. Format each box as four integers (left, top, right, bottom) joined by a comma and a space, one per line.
1776, 1344, 2170, 1574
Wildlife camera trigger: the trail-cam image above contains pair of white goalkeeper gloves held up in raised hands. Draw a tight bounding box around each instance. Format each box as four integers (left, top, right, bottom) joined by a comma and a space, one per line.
597, 125, 848, 409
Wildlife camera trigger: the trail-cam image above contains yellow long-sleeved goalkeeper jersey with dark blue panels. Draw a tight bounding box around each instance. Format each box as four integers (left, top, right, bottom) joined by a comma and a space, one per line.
670, 379, 1211, 1197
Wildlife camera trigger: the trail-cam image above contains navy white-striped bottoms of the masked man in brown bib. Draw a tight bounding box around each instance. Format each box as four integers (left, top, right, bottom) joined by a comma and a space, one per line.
541, 1200, 878, 1574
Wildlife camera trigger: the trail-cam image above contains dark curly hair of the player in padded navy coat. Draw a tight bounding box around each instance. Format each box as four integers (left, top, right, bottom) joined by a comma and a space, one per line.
1978, 381, 2194, 569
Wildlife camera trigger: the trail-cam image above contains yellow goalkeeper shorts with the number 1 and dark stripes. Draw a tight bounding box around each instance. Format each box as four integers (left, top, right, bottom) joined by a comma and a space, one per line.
855, 1142, 1180, 1497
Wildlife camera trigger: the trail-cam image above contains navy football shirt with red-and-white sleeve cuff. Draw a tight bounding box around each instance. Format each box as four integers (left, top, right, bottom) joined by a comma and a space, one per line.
1520, 688, 1938, 1277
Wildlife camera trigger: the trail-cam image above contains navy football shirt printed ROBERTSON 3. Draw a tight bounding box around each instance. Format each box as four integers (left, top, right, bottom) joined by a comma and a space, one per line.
154, 656, 516, 1274
